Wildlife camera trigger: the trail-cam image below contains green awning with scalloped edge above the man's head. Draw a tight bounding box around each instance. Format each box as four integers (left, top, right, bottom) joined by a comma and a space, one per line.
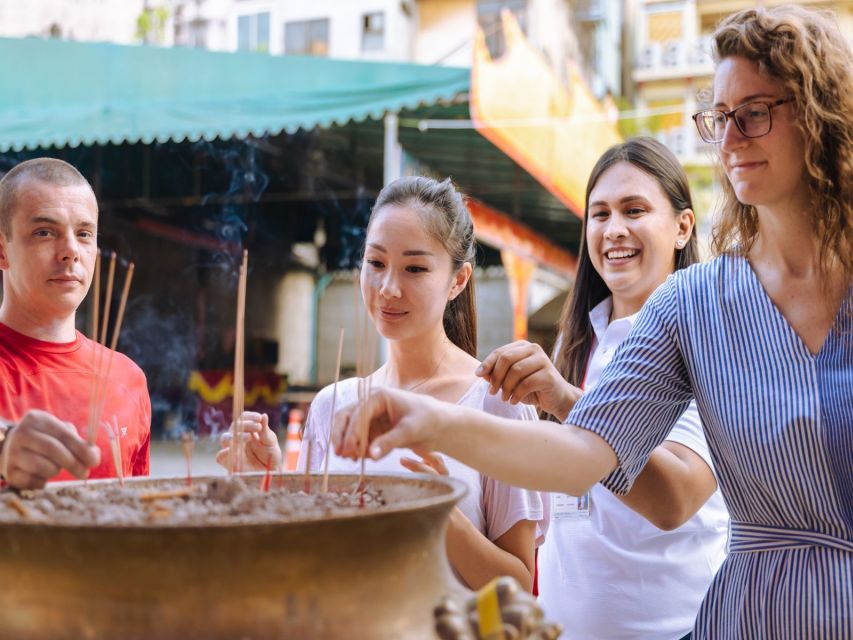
0, 38, 470, 151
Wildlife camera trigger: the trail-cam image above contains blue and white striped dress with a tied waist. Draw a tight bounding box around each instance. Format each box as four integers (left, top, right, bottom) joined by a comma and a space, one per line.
567, 256, 853, 640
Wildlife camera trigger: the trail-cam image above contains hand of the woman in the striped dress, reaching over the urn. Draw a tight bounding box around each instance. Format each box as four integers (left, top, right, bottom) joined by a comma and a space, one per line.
332, 388, 455, 460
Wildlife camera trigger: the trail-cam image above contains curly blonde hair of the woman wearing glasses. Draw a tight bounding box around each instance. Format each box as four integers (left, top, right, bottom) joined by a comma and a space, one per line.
713, 6, 853, 280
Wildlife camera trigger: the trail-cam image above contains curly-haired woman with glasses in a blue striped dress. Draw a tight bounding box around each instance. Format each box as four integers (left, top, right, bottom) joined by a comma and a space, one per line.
335, 7, 853, 640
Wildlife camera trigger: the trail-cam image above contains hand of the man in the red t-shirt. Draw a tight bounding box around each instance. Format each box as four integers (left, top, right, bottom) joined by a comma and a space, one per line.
0, 410, 101, 489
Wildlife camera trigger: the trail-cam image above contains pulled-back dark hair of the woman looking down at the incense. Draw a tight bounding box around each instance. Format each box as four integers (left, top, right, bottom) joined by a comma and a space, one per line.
367, 176, 477, 358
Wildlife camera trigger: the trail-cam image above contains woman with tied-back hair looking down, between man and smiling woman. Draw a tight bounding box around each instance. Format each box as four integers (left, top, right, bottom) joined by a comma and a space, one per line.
217, 177, 544, 590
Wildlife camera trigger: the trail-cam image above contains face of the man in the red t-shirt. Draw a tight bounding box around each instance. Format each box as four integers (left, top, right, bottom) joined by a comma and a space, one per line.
0, 179, 98, 322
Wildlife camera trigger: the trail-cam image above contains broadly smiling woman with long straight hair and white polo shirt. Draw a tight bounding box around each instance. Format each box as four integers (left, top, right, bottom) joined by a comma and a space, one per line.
462, 138, 728, 640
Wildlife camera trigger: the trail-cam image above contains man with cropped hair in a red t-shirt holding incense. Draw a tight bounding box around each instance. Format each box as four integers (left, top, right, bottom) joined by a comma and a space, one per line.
0, 158, 151, 488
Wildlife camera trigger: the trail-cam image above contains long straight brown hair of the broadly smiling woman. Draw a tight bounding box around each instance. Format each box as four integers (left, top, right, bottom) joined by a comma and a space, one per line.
556, 137, 699, 386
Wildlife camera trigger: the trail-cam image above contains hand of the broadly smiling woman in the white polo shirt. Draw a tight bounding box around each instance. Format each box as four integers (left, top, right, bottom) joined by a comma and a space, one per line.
476, 340, 582, 420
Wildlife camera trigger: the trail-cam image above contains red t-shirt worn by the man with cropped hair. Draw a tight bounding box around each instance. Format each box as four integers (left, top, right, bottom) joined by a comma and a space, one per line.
0, 323, 151, 481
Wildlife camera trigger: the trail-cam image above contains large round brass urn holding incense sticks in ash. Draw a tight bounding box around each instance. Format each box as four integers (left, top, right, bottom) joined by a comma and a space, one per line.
0, 474, 470, 640
